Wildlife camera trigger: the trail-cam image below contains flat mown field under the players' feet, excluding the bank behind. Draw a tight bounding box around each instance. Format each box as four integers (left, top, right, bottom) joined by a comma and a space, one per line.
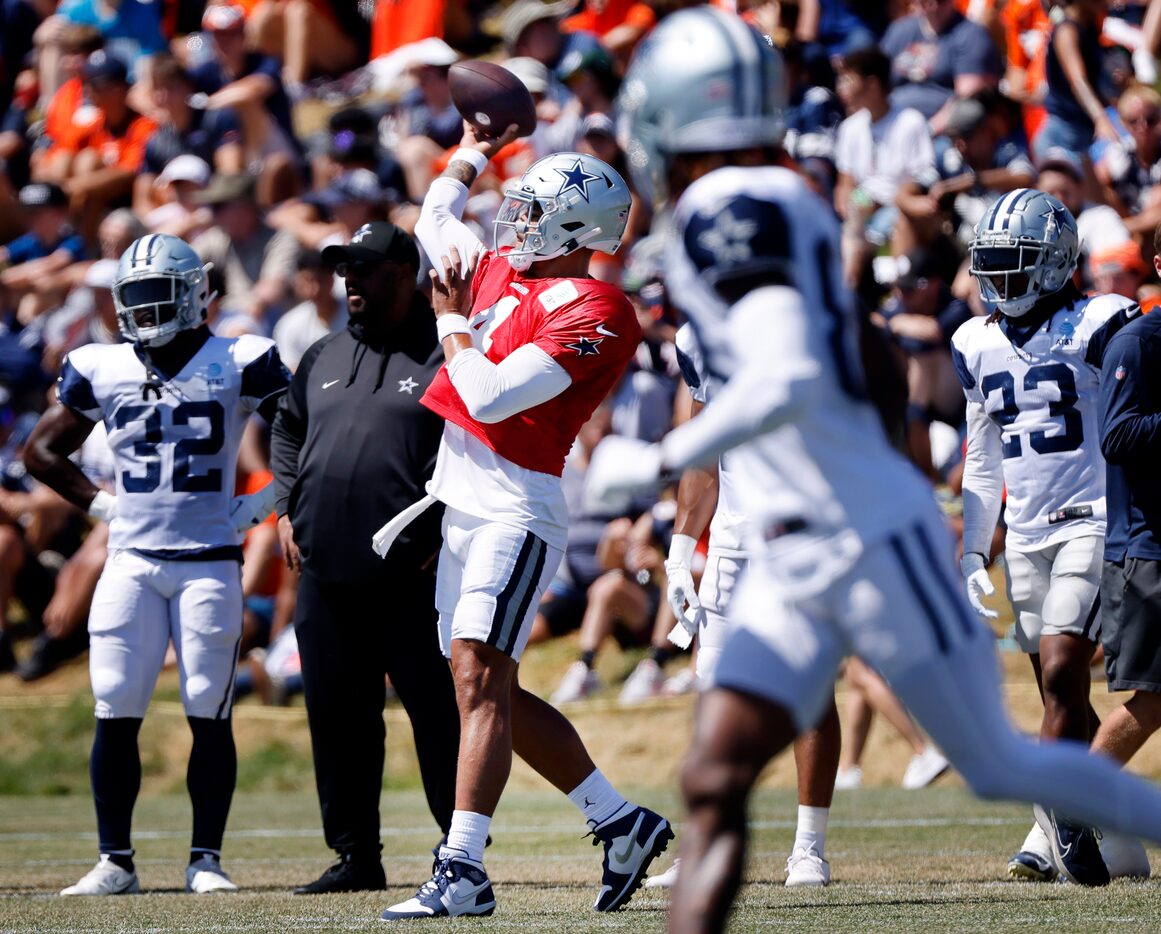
0, 786, 1161, 934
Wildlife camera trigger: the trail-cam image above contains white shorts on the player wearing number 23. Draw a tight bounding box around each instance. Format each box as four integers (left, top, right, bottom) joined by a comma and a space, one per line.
1004, 536, 1104, 654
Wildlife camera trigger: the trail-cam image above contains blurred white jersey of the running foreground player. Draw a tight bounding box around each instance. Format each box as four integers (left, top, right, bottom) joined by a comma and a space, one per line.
663, 167, 931, 555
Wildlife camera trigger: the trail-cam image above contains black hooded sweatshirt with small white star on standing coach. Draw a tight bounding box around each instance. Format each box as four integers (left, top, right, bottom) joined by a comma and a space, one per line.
271, 293, 444, 581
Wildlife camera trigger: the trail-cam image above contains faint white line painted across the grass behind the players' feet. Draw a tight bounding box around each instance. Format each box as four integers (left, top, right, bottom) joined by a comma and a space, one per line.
0, 817, 1027, 843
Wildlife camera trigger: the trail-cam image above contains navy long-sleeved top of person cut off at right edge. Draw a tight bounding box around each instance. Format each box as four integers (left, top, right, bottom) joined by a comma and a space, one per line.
1101, 311, 1161, 563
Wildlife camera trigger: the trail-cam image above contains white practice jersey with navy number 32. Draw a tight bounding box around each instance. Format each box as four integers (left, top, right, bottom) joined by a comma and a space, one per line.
57, 336, 289, 555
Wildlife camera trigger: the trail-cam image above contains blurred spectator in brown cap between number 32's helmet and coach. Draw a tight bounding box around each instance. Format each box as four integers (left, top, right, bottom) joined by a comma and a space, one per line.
192, 174, 298, 333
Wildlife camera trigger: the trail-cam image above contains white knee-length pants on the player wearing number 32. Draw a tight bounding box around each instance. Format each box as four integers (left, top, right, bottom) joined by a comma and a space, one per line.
88, 551, 241, 719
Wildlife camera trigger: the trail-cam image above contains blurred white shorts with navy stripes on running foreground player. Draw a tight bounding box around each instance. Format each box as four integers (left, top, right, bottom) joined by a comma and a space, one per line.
711, 504, 991, 731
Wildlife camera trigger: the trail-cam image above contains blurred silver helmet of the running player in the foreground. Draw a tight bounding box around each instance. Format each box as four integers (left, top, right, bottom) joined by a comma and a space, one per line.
616, 6, 786, 204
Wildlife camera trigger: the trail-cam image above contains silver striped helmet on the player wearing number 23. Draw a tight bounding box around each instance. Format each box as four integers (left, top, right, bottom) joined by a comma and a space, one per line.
971, 188, 1080, 318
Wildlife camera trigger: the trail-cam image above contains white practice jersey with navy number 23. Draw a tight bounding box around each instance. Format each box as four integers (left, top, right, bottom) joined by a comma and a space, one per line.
952, 295, 1135, 554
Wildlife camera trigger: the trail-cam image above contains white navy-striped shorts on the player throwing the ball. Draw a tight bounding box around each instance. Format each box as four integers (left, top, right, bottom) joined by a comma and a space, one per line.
435, 506, 564, 661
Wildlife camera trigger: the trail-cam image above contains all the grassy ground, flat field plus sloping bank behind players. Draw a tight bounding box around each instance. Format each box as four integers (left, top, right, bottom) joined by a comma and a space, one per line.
0, 604, 1161, 934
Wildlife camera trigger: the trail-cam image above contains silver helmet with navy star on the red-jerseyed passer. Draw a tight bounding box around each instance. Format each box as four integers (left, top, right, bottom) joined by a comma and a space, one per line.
495, 152, 632, 271
